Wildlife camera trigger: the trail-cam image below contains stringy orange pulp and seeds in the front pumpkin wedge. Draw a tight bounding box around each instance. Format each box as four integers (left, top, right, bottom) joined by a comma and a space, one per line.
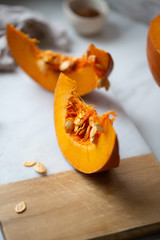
64, 91, 117, 144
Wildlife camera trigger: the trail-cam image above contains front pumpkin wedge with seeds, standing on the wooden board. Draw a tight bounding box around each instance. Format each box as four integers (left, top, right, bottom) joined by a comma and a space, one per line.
54, 73, 119, 174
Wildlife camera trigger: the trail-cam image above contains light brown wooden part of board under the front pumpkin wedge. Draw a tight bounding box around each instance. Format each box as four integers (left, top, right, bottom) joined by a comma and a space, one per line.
0, 154, 160, 240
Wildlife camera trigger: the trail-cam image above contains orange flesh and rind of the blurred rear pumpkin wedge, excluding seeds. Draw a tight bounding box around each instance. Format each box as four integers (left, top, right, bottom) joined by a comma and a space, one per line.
6, 24, 113, 95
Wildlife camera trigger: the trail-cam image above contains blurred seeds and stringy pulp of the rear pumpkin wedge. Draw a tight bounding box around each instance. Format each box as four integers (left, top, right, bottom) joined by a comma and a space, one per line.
37, 49, 110, 90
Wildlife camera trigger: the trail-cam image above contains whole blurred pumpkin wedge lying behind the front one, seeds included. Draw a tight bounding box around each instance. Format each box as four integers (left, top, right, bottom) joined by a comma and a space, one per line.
6, 24, 113, 95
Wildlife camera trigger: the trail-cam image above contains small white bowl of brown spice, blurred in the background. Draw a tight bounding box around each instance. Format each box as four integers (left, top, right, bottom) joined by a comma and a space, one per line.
63, 0, 109, 36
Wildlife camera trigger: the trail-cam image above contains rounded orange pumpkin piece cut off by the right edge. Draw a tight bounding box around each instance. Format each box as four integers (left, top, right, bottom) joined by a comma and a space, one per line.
147, 15, 160, 86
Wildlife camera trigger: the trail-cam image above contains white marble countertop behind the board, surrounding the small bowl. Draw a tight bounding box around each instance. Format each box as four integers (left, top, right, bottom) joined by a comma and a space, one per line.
25, 1, 160, 161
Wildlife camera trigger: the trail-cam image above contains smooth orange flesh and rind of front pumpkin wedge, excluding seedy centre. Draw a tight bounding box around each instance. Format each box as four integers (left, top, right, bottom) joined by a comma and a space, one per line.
54, 73, 119, 174
